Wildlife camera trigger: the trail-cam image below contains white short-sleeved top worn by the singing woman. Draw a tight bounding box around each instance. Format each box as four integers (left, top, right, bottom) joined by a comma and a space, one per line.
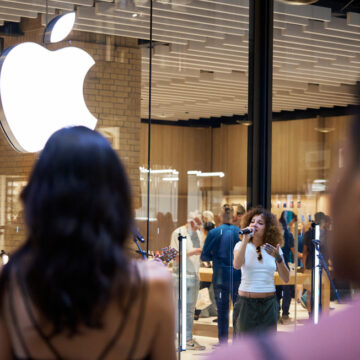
234, 241, 282, 293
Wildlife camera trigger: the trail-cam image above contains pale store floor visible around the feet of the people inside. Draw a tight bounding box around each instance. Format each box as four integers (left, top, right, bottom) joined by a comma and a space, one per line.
181, 299, 348, 360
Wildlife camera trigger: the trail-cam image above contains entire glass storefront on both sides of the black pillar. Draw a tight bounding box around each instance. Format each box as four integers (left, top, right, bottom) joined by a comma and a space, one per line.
0, 0, 360, 358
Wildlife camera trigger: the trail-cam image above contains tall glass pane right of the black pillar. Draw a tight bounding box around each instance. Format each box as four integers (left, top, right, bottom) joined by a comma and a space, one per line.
271, 1, 359, 331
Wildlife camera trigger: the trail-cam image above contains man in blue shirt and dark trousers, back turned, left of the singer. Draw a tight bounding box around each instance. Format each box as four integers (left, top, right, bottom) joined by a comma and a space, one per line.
201, 204, 241, 342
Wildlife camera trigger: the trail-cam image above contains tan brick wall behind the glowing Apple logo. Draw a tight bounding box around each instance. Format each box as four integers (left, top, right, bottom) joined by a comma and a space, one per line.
0, 19, 141, 252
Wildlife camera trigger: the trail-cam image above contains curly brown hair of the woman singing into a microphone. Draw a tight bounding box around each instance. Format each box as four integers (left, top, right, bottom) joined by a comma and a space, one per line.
241, 207, 284, 247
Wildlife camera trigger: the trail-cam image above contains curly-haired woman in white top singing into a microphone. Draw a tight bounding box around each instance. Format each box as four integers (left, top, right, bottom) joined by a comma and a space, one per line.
233, 207, 289, 336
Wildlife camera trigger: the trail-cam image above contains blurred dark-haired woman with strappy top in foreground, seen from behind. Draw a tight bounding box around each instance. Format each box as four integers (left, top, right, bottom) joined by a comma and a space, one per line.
0, 127, 175, 359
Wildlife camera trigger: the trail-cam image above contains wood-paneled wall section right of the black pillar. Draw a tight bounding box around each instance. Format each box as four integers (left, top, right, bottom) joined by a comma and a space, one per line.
271, 116, 352, 194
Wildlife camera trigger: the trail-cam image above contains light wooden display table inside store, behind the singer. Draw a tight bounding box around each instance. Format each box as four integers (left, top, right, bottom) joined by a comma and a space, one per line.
200, 268, 330, 312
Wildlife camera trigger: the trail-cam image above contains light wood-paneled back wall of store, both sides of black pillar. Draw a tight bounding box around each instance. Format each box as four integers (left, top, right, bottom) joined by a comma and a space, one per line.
140, 116, 351, 249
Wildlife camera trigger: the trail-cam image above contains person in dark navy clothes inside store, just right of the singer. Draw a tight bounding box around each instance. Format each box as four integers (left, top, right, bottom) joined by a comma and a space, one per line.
276, 210, 296, 322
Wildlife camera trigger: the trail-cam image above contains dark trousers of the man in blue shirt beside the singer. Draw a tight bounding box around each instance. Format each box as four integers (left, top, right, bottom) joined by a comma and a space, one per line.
214, 281, 240, 342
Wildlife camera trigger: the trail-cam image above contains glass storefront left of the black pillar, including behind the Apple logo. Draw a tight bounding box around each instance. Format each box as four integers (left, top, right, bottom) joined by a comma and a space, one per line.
0, 0, 249, 356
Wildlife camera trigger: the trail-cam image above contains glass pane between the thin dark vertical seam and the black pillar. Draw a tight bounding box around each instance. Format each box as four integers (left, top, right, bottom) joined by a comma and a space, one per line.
140, 0, 248, 352
